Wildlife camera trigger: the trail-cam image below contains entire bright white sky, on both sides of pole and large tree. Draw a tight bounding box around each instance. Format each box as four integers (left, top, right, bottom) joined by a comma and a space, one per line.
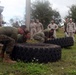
0, 0, 76, 21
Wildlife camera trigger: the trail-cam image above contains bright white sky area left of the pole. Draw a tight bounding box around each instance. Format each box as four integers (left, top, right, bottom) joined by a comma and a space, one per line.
0, 0, 25, 21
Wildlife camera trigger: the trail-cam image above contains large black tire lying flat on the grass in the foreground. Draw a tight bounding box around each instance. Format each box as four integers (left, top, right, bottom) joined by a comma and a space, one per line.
11, 44, 61, 63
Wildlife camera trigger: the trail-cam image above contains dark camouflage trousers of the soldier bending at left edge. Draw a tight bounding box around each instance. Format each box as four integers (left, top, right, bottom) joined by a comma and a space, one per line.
0, 35, 15, 55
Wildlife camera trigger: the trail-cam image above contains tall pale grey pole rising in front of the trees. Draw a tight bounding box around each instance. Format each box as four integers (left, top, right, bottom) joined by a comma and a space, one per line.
25, 0, 31, 30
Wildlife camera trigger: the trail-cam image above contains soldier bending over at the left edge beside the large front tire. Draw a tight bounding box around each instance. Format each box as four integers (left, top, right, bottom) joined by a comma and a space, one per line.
0, 27, 26, 63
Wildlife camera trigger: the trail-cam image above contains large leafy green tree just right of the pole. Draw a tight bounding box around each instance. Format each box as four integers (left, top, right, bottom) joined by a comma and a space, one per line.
31, 0, 59, 27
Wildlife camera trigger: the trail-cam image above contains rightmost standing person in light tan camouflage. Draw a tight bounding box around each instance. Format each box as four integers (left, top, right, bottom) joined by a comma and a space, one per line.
67, 18, 75, 41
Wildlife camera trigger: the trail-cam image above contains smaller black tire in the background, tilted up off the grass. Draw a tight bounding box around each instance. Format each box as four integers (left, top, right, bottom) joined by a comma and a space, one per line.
45, 37, 74, 48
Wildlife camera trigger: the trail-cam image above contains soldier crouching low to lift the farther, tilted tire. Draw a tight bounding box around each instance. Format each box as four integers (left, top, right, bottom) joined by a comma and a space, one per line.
33, 29, 54, 42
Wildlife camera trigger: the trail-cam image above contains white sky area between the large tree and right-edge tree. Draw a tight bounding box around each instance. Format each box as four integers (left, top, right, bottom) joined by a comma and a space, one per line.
49, 0, 76, 18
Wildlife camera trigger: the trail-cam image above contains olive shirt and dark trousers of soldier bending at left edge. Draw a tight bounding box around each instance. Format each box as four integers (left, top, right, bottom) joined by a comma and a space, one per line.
0, 27, 18, 55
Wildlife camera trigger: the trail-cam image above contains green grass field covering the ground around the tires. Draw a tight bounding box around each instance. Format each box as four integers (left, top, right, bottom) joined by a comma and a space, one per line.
0, 30, 76, 75
